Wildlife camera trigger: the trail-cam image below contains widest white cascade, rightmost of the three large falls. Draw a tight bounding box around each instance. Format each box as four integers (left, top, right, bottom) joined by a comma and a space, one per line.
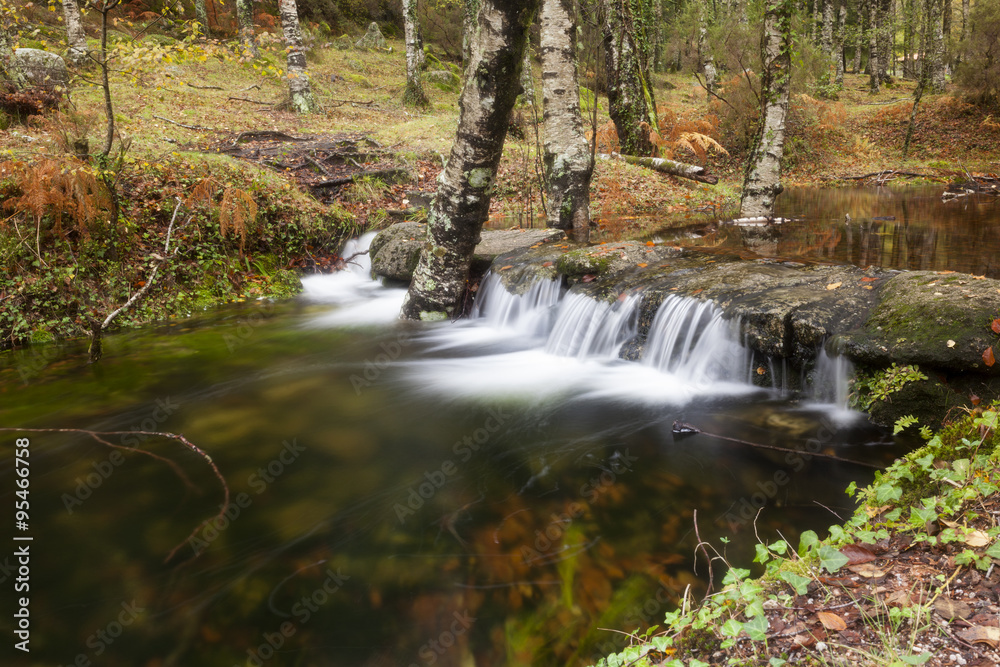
642, 295, 749, 383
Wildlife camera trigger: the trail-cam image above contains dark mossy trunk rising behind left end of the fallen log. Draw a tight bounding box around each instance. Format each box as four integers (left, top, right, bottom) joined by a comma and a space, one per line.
601, 0, 656, 155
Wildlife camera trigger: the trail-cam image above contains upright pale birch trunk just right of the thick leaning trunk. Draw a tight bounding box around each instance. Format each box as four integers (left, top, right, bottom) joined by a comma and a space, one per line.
541, 0, 594, 243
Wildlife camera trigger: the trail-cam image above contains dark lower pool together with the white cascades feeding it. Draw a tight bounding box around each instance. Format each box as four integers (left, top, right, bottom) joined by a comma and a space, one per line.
0, 226, 916, 667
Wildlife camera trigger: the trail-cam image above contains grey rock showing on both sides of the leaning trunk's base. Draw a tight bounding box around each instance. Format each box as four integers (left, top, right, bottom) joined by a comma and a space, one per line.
369, 222, 565, 282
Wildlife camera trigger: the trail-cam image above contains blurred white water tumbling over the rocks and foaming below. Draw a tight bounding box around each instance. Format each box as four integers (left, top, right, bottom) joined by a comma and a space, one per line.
303, 234, 849, 407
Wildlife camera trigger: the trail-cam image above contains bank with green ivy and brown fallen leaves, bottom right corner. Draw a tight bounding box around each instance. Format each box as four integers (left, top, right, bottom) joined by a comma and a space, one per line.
598, 404, 1000, 667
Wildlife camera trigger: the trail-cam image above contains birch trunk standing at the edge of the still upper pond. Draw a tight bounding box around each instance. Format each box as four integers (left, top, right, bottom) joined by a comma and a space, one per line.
740, 0, 792, 218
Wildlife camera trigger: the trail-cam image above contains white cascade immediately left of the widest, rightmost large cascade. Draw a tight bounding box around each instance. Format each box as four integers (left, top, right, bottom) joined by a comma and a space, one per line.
545, 294, 641, 359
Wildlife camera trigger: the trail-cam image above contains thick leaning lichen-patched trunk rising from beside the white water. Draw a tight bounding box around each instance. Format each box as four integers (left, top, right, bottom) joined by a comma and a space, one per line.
400, 0, 538, 321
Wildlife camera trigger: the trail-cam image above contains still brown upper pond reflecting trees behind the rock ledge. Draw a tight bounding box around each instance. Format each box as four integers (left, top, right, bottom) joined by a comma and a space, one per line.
660, 186, 1000, 278
